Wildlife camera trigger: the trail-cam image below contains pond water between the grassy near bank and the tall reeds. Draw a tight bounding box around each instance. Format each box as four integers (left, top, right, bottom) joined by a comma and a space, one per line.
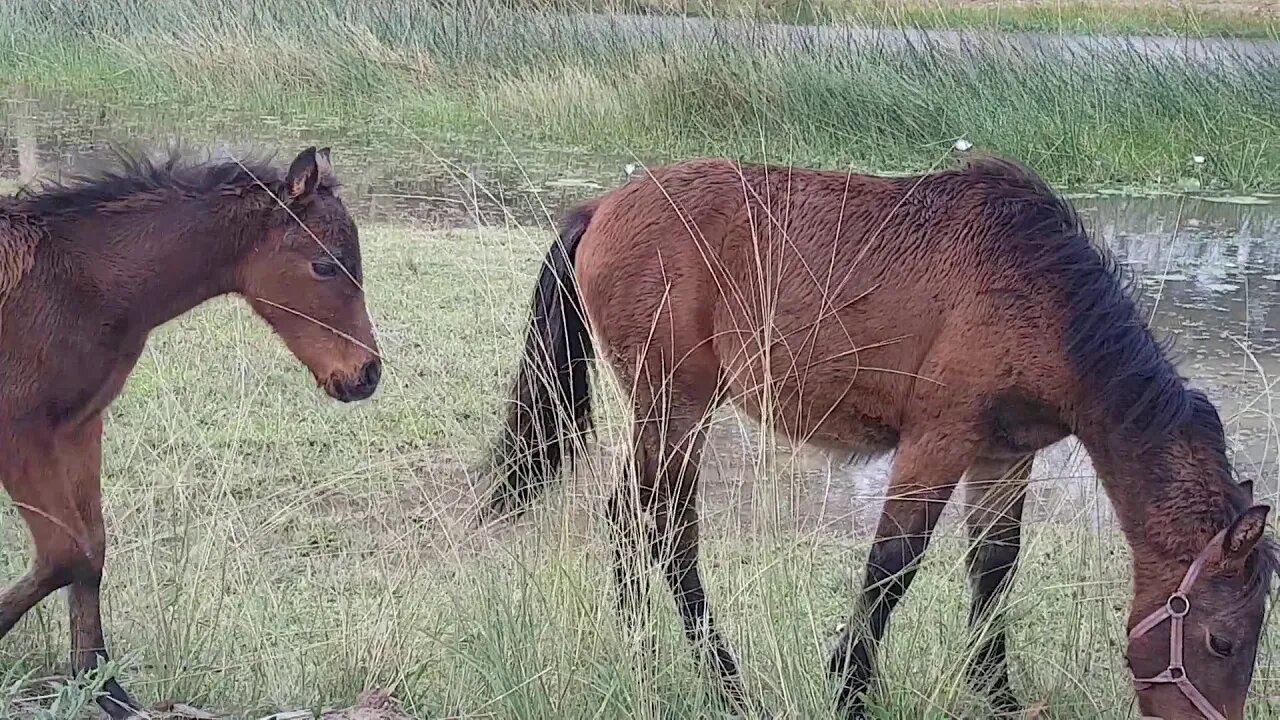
0, 101, 1280, 532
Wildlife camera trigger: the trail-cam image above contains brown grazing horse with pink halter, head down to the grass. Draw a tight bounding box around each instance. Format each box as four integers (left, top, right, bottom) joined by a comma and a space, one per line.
488, 159, 1276, 719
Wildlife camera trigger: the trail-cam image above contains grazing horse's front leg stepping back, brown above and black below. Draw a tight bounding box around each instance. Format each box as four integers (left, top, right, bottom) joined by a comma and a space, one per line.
828, 434, 972, 717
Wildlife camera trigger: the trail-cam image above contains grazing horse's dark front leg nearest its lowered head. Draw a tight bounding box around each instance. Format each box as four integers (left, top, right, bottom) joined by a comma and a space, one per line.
965, 455, 1034, 715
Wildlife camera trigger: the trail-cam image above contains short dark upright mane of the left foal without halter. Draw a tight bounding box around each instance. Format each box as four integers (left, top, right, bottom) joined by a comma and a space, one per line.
15, 146, 332, 217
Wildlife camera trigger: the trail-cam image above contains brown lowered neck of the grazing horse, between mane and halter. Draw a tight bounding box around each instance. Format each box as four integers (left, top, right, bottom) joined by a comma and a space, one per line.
1076, 409, 1231, 577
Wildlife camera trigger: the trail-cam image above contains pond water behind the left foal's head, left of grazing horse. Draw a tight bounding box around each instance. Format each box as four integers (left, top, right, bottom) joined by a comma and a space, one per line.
0, 92, 619, 227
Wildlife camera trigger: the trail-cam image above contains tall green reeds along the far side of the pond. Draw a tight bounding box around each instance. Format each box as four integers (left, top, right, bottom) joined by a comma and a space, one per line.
0, 0, 1280, 190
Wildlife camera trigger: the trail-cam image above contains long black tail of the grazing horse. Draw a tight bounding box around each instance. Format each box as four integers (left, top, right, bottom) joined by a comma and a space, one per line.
483, 198, 595, 518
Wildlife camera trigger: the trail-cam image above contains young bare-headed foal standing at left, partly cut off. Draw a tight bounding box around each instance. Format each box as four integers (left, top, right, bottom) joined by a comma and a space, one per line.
0, 147, 381, 719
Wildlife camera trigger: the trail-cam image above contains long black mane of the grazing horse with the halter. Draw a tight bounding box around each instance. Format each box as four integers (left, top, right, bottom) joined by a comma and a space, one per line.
960, 158, 1280, 597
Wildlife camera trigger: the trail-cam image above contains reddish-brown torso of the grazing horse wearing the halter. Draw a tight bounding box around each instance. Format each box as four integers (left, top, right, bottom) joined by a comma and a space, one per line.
580, 160, 1078, 454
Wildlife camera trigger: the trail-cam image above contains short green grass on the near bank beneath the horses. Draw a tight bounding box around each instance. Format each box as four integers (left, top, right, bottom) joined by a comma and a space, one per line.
0, 225, 1280, 720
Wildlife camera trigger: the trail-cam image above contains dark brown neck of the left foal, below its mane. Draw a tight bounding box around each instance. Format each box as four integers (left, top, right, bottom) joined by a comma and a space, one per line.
55, 199, 265, 332
